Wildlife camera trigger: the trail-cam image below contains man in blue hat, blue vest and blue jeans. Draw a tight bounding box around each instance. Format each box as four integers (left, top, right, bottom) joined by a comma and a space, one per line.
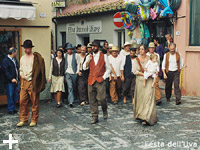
65, 43, 80, 107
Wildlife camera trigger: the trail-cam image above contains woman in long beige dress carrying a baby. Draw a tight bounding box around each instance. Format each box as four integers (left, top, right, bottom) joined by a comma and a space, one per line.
133, 45, 157, 125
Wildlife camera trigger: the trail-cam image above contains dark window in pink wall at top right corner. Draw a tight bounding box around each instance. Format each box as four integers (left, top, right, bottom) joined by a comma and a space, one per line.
190, 0, 200, 46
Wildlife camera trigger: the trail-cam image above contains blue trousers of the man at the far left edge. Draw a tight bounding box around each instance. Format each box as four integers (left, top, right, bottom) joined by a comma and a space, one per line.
6, 83, 19, 111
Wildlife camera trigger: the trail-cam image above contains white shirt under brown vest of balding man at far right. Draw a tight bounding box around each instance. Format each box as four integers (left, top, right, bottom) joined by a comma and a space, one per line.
162, 53, 183, 71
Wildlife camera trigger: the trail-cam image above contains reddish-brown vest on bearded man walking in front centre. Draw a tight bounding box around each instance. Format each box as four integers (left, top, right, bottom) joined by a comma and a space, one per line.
88, 52, 106, 85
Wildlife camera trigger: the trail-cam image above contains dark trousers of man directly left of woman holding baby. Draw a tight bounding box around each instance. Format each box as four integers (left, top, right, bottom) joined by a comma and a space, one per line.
122, 74, 136, 98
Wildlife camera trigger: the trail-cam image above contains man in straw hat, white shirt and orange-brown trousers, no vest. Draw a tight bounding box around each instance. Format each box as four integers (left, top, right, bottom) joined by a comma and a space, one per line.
108, 46, 123, 104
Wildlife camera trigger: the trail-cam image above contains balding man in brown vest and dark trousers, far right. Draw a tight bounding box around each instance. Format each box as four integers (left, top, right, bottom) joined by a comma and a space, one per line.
162, 43, 183, 105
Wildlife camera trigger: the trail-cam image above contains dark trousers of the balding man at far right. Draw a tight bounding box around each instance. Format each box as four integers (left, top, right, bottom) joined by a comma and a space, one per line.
165, 71, 181, 101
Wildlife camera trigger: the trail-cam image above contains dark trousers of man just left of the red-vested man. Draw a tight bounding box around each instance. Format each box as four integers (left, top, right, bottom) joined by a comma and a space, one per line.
78, 76, 88, 102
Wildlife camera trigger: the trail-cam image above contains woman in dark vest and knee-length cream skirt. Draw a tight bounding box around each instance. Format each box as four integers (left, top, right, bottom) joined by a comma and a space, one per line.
48, 49, 65, 108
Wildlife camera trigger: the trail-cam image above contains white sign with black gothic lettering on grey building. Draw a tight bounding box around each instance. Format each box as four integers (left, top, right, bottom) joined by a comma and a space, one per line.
67, 21, 102, 34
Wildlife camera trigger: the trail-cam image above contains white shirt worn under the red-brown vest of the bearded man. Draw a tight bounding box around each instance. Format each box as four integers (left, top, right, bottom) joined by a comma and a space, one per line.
83, 51, 111, 80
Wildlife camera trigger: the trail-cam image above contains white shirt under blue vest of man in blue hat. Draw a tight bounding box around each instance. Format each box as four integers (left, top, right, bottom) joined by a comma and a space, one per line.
65, 54, 80, 74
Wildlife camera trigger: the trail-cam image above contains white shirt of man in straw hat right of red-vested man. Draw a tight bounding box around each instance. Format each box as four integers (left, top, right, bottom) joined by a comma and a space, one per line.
108, 55, 124, 77
